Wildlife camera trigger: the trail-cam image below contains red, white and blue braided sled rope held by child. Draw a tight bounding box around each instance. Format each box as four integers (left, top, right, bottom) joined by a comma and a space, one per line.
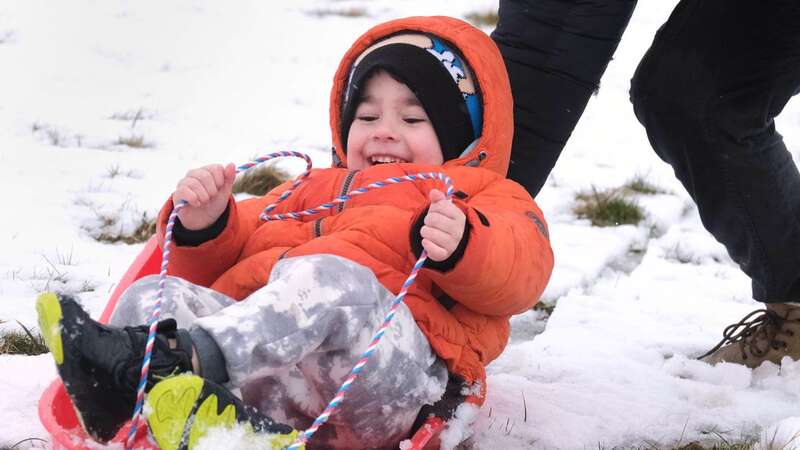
125, 151, 453, 450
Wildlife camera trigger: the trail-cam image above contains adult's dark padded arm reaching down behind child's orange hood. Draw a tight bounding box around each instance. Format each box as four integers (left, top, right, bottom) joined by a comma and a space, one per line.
492, 0, 636, 196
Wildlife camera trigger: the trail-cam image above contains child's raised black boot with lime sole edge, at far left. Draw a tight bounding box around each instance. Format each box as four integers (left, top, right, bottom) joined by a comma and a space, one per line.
36, 293, 193, 443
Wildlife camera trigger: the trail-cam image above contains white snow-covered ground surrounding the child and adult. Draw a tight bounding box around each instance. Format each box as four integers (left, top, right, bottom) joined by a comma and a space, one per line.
0, 0, 800, 449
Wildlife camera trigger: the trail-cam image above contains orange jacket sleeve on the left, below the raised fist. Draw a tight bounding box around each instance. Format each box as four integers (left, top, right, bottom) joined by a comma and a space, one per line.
156, 181, 300, 287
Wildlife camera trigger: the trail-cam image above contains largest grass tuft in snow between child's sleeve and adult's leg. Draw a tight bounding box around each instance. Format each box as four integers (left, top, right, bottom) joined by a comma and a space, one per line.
573, 187, 645, 227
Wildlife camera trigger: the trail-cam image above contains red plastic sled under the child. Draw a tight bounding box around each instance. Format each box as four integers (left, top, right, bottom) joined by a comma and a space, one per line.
39, 237, 444, 450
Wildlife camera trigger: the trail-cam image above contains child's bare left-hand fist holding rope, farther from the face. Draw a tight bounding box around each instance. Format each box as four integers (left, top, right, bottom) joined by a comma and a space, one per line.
172, 164, 236, 230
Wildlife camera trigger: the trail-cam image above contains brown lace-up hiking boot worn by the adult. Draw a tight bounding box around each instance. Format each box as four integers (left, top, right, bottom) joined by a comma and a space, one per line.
698, 303, 800, 368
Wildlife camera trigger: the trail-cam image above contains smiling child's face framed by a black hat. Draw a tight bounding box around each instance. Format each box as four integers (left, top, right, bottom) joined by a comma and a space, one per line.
347, 71, 444, 169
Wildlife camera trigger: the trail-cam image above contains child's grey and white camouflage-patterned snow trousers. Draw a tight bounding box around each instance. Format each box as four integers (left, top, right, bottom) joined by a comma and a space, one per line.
111, 255, 448, 448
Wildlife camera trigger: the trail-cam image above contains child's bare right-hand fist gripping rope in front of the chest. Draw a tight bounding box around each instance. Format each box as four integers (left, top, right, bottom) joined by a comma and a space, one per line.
420, 189, 467, 262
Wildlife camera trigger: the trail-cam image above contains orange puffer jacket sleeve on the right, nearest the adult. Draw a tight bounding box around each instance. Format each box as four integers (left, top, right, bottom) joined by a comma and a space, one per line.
425, 179, 553, 316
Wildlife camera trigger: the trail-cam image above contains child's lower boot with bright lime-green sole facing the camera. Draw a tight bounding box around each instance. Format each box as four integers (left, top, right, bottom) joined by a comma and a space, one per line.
145, 374, 297, 450
